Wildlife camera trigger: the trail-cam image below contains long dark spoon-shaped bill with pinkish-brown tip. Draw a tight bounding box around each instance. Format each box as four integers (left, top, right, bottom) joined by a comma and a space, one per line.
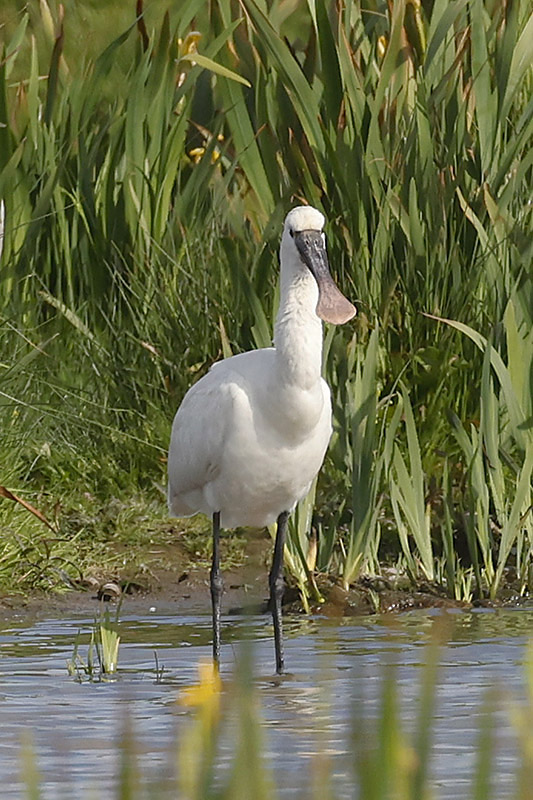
294, 231, 356, 325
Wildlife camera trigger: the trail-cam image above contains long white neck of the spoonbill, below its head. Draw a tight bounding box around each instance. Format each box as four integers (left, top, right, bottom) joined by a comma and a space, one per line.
274, 270, 322, 390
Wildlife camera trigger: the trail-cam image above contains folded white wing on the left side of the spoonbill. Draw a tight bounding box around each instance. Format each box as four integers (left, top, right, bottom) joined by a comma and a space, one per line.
168, 369, 234, 515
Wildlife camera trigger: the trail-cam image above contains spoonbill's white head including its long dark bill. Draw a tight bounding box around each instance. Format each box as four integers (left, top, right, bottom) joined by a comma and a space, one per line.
281, 206, 356, 325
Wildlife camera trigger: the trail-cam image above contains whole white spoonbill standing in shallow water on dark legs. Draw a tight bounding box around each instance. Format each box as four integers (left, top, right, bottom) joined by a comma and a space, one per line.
168, 206, 355, 673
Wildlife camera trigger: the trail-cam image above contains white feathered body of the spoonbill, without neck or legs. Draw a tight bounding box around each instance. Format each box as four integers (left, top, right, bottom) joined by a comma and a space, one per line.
169, 348, 331, 528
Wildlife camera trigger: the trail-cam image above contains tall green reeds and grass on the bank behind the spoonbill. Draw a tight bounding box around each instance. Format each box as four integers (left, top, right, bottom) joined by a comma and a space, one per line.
0, 0, 533, 600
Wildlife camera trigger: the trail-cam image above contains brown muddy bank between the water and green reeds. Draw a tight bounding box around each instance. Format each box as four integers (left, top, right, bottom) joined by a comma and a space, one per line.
0, 532, 523, 617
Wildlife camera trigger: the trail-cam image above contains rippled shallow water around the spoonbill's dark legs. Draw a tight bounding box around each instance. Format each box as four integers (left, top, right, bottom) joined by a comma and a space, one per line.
0, 600, 533, 800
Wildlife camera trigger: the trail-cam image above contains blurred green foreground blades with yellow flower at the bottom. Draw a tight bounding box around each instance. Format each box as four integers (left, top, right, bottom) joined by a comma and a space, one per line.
19, 625, 533, 800
